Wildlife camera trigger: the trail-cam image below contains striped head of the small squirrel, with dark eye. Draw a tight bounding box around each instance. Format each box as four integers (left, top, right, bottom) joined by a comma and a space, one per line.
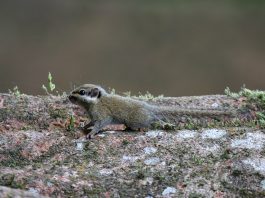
68, 84, 107, 106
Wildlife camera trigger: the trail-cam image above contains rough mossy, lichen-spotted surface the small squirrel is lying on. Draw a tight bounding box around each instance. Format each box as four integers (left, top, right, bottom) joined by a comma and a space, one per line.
0, 94, 265, 198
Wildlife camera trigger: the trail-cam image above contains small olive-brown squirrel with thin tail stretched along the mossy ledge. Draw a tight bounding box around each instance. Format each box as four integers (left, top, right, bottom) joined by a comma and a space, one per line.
68, 84, 231, 139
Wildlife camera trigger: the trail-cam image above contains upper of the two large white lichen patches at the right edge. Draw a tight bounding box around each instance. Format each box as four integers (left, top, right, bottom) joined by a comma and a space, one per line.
231, 132, 265, 150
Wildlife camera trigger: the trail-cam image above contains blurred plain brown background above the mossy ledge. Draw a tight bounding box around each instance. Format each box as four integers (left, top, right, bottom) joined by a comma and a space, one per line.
0, 0, 265, 96
